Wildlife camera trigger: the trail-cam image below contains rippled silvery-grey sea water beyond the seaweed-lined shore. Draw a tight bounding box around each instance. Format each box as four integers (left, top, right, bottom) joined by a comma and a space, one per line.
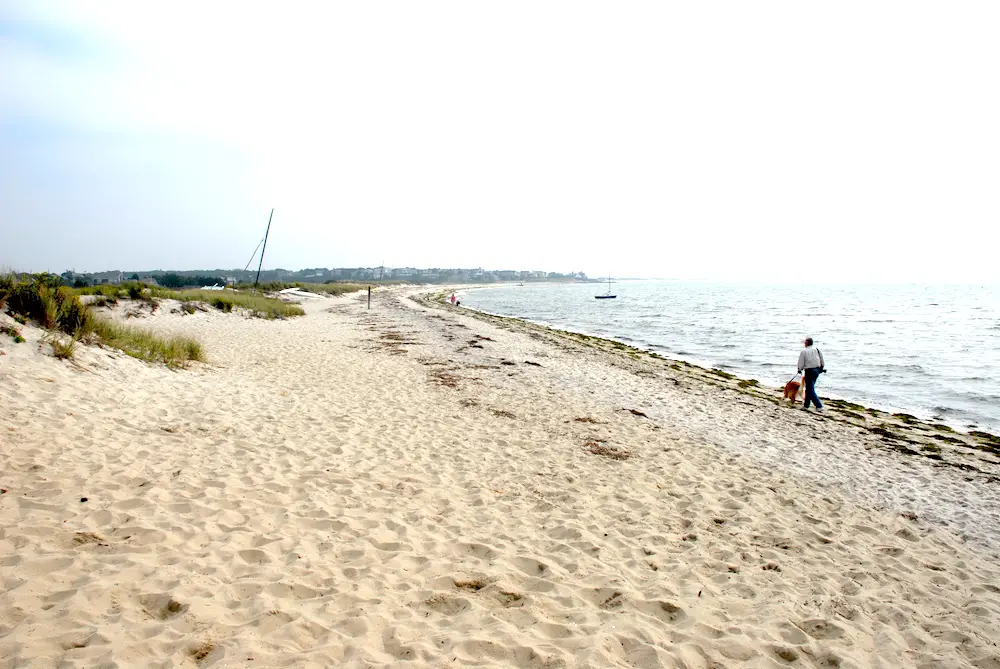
460, 281, 1000, 434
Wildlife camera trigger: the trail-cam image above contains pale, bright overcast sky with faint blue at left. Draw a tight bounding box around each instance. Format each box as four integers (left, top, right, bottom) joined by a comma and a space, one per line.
0, 0, 1000, 282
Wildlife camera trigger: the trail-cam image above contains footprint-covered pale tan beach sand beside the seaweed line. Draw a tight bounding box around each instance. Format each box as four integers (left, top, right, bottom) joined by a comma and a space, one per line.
0, 289, 1000, 669
